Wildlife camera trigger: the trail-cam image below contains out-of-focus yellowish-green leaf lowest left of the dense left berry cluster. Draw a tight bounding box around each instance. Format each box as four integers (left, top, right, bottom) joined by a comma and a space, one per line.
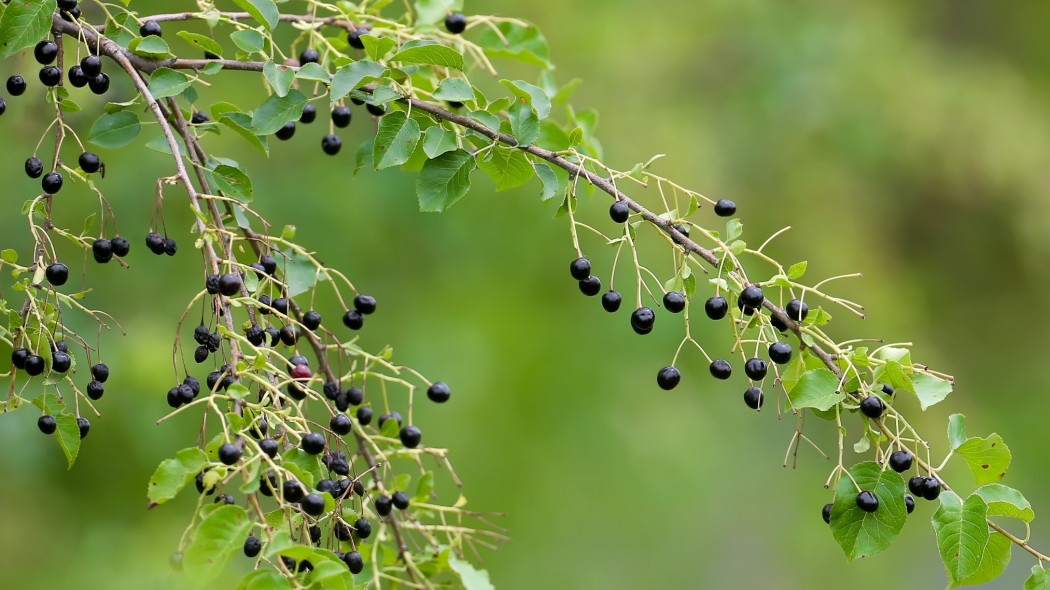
183, 505, 252, 586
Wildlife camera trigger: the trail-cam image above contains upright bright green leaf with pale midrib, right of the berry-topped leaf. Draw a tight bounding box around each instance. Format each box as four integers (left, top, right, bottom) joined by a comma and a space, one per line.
933, 491, 988, 586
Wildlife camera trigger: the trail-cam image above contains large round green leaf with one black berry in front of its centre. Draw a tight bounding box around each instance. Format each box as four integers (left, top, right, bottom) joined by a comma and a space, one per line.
832, 461, 907, 561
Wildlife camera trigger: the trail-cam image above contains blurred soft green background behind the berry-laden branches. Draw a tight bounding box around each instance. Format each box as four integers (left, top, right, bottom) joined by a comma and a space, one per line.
0, 0, 1050, 590
